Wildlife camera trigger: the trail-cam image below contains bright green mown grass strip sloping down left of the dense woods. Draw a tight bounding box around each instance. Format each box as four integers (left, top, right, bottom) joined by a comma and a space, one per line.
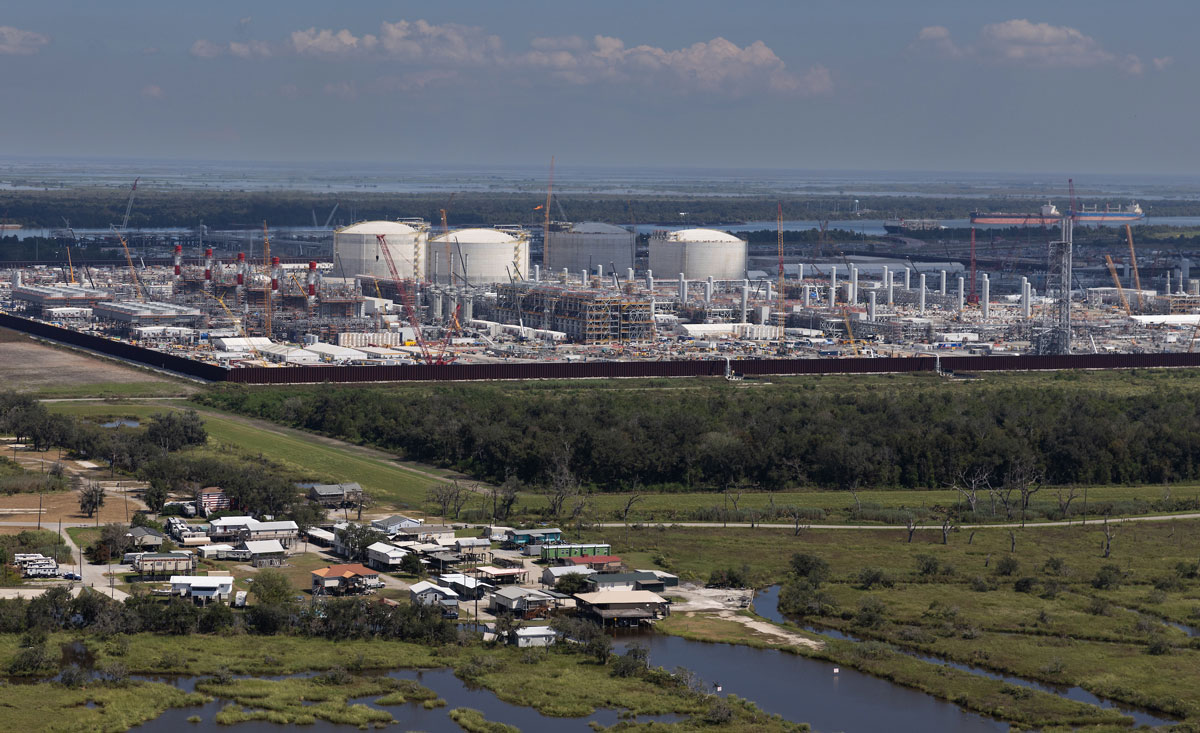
48, 402, 438, 509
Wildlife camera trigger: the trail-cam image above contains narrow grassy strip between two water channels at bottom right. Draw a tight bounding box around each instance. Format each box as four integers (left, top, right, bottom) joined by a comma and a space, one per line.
660, 614, 1130, 729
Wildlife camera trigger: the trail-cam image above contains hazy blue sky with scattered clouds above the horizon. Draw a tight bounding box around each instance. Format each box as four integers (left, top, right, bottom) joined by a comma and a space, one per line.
0, 0, 1200, 174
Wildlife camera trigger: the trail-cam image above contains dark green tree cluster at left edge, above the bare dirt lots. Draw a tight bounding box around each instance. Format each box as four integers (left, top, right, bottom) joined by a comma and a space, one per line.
0, 392, 208, 471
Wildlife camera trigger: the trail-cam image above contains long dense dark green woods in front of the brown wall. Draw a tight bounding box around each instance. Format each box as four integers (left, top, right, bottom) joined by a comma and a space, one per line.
203, 374, 1200, 494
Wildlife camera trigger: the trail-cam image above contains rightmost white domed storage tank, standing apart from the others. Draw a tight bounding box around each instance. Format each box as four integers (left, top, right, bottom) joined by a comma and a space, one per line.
650, 229, 746, 280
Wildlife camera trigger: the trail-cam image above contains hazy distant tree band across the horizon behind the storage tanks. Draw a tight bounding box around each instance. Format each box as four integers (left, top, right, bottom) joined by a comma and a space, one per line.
0, 185, 1200, 228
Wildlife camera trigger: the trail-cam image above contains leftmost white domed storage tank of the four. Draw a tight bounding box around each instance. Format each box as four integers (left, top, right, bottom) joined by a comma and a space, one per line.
334, 220, 430, 281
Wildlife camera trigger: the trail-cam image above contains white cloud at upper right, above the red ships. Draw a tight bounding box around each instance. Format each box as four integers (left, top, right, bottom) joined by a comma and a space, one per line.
913, 18, 1158, 76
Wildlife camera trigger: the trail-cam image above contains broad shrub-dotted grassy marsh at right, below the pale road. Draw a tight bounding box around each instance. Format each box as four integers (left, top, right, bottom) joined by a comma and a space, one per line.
600, 519, 1200, 726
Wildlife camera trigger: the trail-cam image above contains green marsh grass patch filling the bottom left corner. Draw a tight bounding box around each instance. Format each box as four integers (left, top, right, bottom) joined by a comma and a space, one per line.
0, 681, 204, 733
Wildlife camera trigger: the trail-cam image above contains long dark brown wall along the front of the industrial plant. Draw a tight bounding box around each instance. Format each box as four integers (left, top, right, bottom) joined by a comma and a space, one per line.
7, 313, 1200, 384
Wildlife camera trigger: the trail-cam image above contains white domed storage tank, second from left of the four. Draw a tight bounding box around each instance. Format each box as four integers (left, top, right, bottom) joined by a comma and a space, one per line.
428, 229, 529, 286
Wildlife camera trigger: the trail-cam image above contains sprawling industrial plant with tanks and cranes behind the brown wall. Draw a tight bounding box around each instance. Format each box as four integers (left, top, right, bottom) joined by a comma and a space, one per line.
0, 193, 1200, 381
